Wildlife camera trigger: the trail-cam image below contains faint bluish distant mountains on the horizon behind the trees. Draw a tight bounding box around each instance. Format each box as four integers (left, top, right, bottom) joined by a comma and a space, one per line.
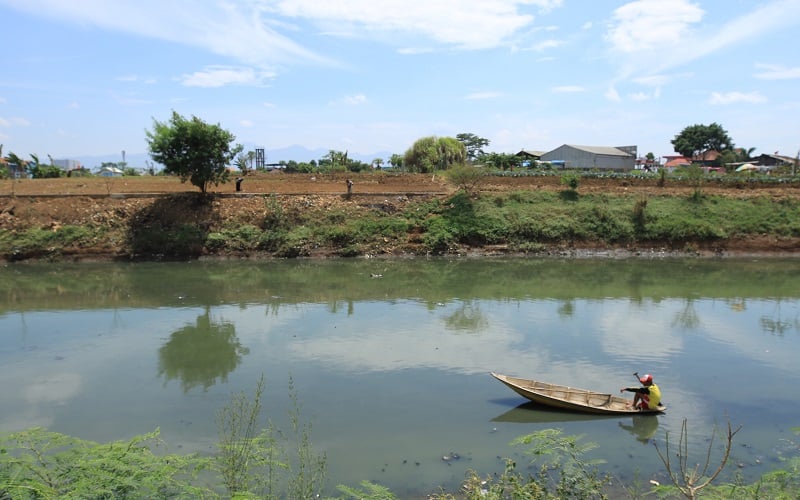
74, 144, 393, 170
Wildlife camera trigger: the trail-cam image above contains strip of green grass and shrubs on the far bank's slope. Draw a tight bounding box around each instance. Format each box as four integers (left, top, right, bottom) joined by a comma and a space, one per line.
0, 188, 800, 260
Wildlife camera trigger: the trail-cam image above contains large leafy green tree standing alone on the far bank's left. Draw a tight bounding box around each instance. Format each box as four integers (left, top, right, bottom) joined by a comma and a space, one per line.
147, 111, 242, 193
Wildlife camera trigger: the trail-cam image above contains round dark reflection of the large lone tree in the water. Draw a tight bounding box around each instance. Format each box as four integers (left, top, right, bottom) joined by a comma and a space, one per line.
158, 307, 250, 392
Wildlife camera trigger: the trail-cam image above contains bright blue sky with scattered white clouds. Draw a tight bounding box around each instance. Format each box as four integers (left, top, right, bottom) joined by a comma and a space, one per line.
0, 0, 800, 161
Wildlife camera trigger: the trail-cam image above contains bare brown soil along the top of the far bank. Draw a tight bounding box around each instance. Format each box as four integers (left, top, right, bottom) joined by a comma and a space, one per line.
0, 171, 800, 256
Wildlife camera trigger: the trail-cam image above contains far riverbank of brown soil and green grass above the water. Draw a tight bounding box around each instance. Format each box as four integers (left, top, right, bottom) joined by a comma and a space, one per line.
0, 173, 800, 261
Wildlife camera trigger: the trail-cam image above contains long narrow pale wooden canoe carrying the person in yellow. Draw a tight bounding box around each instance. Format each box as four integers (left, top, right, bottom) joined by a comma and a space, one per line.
492, 372, 667, 415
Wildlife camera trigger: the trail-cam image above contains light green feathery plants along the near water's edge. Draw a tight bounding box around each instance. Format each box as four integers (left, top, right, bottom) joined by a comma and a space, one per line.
0, 394, 800, 500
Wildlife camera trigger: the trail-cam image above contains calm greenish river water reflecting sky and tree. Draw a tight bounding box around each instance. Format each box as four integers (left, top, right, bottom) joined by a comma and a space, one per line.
0, 259, 800, 497
